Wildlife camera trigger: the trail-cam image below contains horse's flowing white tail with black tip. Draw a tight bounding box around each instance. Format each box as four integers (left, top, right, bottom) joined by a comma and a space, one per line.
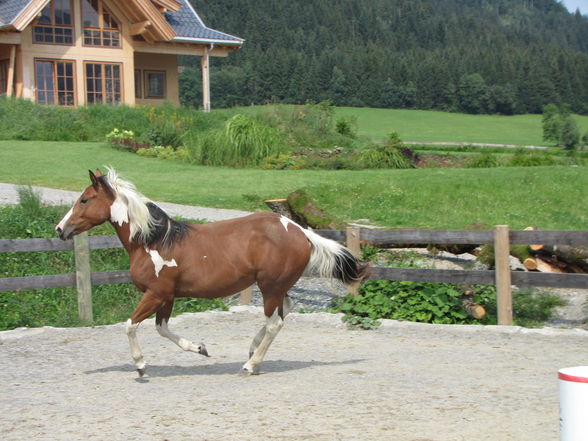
302, 229, 368, 284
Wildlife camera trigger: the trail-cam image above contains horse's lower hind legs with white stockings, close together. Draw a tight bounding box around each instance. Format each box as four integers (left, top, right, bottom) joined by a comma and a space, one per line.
242, 296, 292, 375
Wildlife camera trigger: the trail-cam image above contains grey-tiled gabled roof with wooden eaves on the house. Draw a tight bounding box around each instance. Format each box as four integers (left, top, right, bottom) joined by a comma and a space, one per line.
0, 0, 243, 46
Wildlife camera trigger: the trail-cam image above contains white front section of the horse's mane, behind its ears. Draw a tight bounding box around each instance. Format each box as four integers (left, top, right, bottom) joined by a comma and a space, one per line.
106, 167, 153, 240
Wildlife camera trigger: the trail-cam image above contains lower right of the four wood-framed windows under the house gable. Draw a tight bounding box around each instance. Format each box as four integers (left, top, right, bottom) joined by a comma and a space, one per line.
85, 63, 122, 104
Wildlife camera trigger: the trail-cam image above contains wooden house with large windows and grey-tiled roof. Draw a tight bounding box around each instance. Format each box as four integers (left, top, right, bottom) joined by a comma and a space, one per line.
0, 0, 243, 110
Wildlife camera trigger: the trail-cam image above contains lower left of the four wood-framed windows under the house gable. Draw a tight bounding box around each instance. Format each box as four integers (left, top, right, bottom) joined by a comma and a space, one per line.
35, 60, 75, 106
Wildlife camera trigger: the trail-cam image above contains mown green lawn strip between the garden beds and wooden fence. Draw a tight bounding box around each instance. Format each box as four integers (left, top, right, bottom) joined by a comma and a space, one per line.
0, 141, 588, 229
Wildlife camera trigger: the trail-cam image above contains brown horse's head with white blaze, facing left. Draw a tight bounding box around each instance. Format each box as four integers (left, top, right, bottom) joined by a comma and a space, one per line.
55, 170, 116, 240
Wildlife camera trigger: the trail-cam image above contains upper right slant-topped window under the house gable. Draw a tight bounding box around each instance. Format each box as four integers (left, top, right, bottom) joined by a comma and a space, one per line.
82, 0, 120, 47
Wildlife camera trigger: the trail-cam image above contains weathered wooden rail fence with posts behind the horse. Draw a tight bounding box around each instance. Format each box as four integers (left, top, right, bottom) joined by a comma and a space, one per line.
0, 225, 588, 325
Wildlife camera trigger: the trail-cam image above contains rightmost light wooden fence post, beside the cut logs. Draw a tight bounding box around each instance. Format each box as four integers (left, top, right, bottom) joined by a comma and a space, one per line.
494, 225, 512, 325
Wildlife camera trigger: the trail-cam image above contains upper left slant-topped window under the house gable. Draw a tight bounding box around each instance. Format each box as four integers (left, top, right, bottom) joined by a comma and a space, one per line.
33, 0, 73, 45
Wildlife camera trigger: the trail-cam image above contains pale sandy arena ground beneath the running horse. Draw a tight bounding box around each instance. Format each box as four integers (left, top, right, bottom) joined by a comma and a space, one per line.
0, 307, 588, 441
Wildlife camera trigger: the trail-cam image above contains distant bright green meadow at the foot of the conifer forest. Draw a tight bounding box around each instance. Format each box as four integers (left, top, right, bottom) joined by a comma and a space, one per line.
336, 107, 588, 145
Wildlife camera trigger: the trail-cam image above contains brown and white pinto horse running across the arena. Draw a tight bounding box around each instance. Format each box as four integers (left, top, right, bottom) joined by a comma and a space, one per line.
55, 168, 367, 377
